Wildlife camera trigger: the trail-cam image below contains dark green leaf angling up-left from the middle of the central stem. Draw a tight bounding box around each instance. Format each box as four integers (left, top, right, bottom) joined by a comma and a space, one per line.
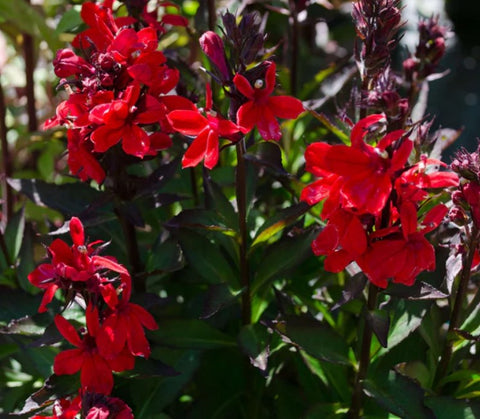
173, 229, 239, 286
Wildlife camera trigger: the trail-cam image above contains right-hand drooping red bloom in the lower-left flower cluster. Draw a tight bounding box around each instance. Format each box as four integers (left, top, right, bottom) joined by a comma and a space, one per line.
97, 276, 158, 358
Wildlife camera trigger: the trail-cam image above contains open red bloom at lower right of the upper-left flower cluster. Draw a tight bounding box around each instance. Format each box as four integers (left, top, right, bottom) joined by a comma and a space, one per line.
90, 84, 165, 157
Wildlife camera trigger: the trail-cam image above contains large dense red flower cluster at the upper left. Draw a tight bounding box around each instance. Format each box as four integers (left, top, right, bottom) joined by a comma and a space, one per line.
44, 1, 191, 183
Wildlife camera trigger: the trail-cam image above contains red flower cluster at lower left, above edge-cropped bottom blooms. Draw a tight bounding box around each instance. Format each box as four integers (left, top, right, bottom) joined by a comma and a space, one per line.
28, 217, 157, 414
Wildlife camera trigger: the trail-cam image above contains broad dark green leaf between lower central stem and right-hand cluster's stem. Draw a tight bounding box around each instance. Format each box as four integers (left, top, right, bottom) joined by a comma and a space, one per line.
276, 317, 350, 364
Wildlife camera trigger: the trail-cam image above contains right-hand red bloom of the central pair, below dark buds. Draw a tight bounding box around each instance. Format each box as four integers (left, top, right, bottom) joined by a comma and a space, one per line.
233, 63, 304, 141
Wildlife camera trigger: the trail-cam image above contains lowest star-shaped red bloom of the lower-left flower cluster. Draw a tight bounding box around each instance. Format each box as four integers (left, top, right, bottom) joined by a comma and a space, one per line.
53, 306, 135, 394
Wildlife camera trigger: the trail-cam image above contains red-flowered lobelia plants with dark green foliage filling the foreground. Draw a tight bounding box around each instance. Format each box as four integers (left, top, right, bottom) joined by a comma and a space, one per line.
0, 0, 480, 419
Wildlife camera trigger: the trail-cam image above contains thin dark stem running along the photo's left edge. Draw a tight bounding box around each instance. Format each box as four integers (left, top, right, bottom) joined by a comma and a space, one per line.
0, 74, 13, 226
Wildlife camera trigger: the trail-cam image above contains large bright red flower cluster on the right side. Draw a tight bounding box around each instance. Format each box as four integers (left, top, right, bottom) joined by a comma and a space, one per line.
301, 114, 458, 288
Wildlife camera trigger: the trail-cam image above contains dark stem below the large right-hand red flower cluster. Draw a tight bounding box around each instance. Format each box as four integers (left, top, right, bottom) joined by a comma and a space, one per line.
348, 283, 378, 419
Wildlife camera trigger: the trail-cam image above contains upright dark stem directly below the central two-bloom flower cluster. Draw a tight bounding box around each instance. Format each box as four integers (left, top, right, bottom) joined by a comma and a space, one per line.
235, 139, 252, 324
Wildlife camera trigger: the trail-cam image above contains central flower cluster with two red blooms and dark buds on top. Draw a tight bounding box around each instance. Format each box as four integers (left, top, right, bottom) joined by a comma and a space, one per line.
167, 13, 304, 169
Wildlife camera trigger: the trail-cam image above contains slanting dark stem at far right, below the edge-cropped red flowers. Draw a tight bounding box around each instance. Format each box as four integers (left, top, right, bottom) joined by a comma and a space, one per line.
434, 226, 479, 388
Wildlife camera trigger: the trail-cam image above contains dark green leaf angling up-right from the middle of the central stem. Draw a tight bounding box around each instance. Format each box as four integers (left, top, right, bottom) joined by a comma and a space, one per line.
252, 229, 318, 295
